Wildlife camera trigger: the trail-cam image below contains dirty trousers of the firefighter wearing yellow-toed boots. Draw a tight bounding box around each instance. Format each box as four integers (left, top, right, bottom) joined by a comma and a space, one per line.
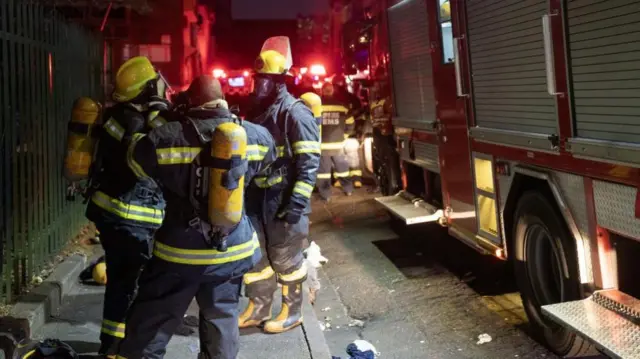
244, 215, 309, 298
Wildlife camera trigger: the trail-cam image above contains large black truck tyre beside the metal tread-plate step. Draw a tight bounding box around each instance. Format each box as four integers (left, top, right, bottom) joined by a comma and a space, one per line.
511, 191, 594, 357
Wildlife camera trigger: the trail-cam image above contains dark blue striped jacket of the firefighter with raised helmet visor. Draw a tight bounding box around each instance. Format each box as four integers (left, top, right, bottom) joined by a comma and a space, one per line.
250, 86, 320, 216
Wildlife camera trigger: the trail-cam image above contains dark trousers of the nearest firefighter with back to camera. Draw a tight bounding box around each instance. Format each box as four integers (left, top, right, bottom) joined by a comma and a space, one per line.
117, 252, 257, 359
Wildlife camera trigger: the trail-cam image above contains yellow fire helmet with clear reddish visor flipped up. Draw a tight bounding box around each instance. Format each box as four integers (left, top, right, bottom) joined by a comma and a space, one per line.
254, 36, 293, 75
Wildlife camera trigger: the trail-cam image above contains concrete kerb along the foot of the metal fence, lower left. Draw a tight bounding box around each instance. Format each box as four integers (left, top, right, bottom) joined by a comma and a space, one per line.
0, 254, 87, 338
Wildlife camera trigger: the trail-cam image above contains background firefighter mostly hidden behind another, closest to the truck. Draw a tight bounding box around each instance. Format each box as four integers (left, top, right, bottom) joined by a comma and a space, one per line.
331, 74, 364, 188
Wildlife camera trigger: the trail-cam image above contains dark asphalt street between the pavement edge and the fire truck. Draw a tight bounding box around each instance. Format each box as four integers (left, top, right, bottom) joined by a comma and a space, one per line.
310, 189, 556, 359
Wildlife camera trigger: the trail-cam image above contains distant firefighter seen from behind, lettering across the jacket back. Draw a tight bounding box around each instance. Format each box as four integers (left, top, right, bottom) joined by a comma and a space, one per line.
318, 83, 355, 201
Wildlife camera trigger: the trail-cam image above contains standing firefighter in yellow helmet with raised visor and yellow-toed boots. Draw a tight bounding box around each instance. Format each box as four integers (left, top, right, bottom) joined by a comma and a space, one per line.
238, 37, 320, 333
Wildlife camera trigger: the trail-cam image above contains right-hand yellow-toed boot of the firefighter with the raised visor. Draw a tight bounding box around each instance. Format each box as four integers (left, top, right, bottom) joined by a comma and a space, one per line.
264, 283, 302, 334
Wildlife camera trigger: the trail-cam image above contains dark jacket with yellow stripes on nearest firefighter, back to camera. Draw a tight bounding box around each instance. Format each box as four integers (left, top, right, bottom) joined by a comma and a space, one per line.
128, 107, 276, 265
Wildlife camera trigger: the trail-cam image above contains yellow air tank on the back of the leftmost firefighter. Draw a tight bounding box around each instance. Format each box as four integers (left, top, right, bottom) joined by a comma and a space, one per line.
63, 97, 101, 182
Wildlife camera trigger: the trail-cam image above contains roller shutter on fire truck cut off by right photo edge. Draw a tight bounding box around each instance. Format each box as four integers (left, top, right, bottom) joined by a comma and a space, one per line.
567, 0, 640, 142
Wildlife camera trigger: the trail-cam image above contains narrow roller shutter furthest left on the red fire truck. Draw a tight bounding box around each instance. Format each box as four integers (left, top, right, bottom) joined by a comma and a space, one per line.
388, 0, 436, 130
